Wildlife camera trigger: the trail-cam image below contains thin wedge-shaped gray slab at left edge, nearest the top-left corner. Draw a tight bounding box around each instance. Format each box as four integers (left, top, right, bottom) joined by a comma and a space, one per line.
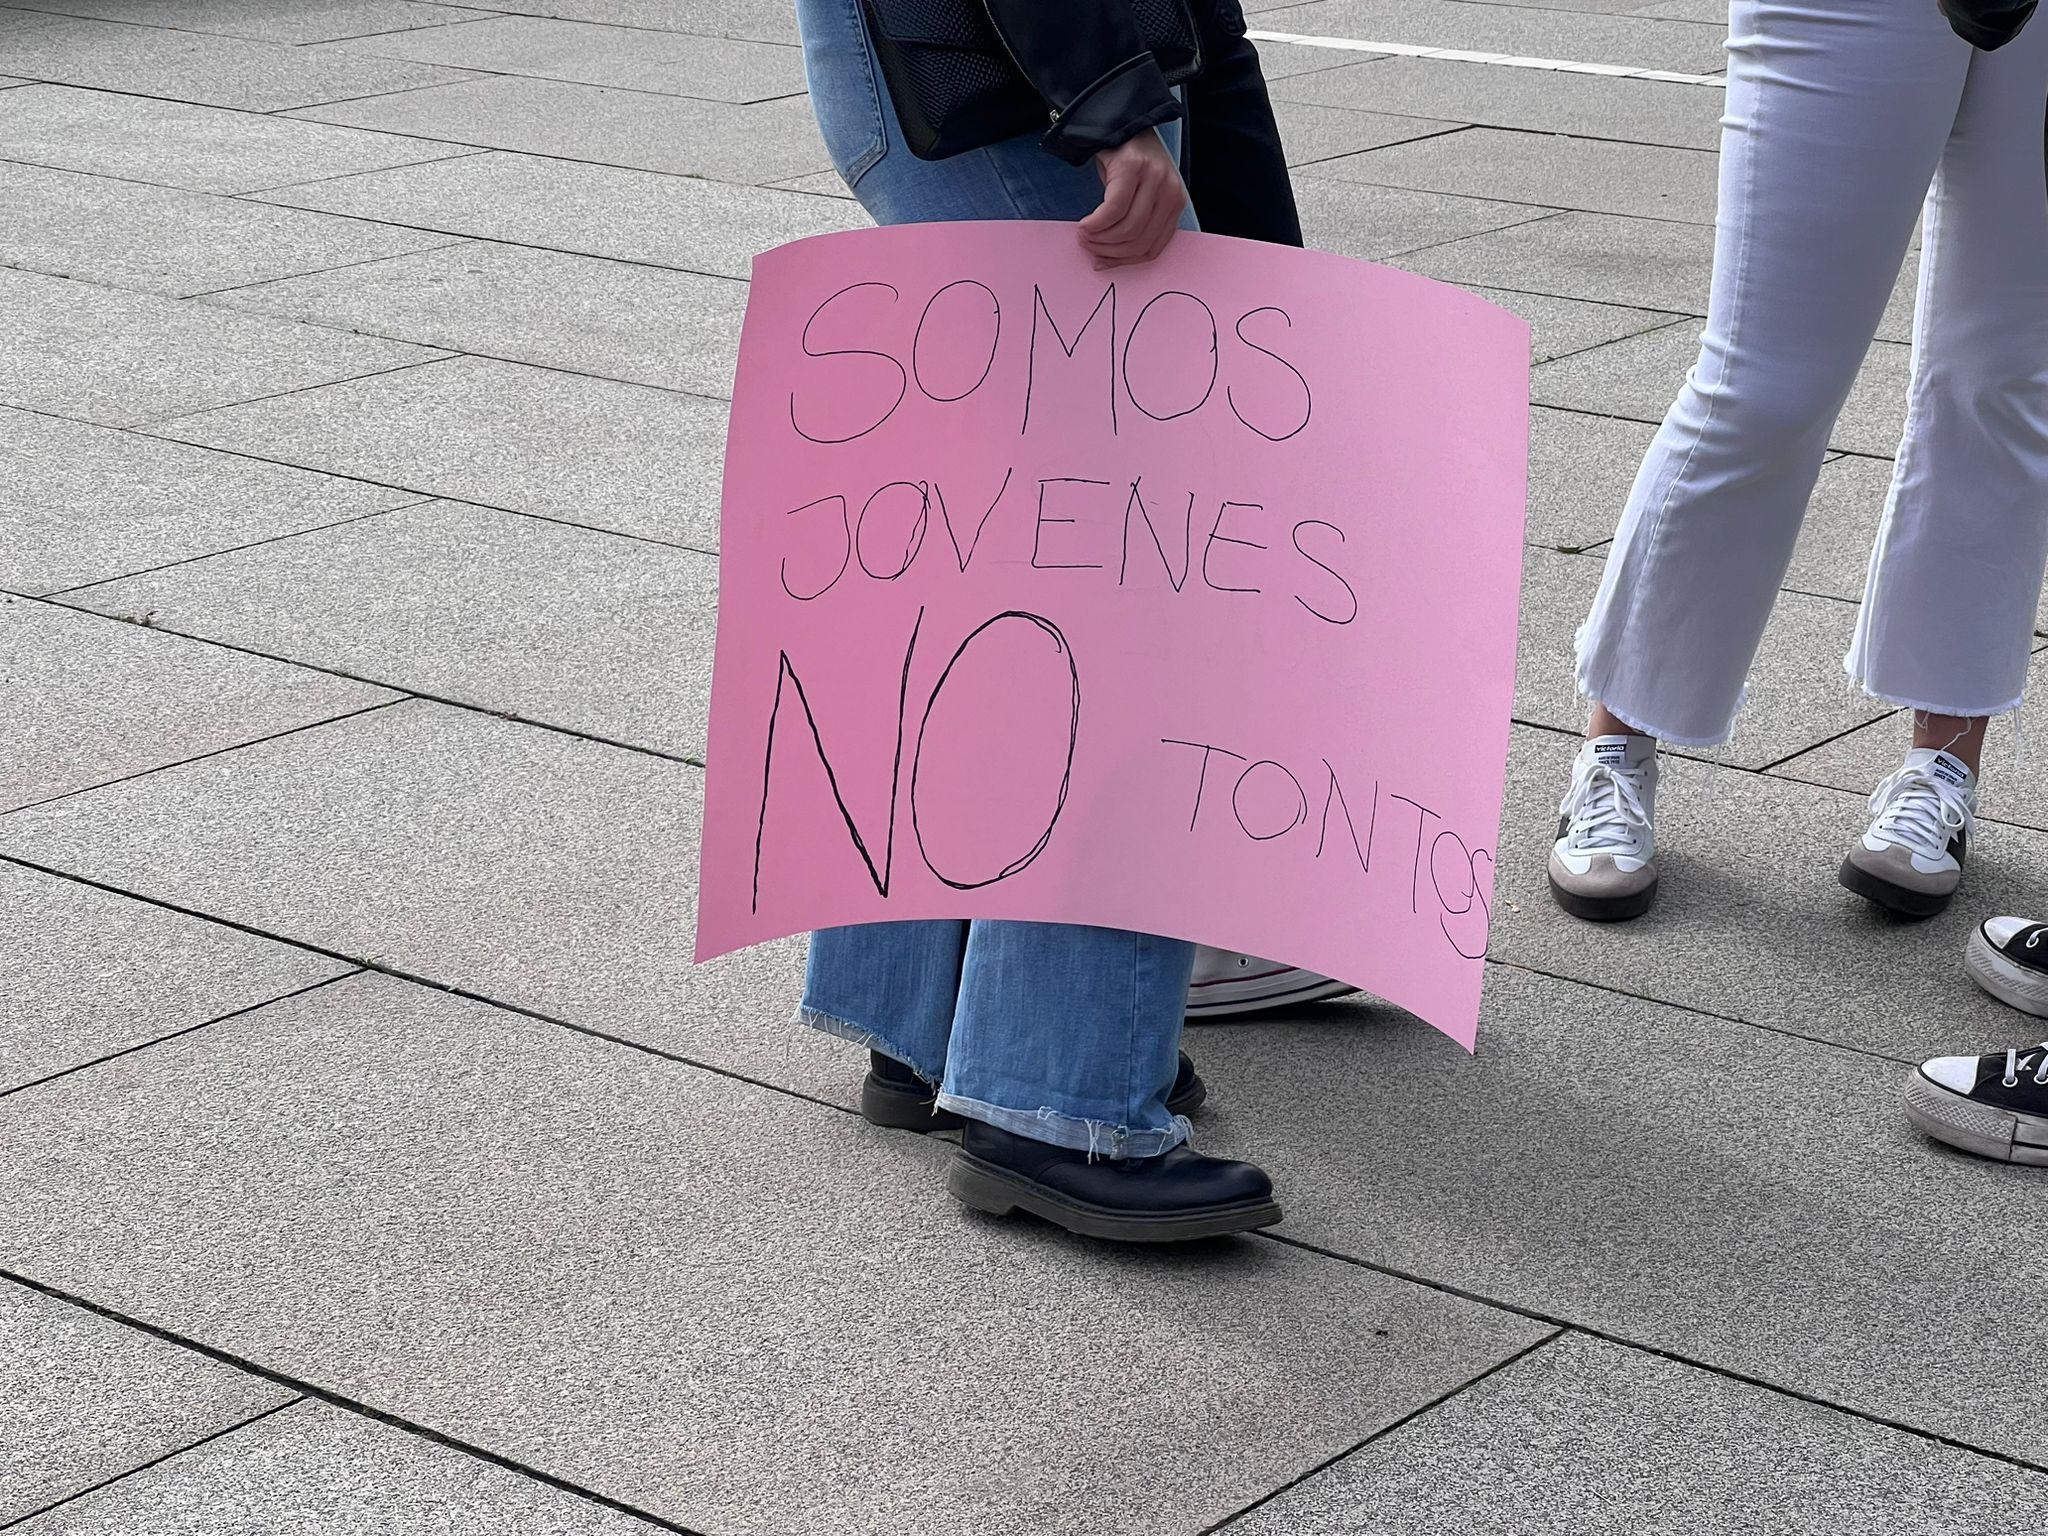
0, 10, 465, 113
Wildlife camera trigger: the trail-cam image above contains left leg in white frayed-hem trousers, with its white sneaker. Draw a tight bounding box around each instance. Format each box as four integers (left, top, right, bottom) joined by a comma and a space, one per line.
1550, 0, 1970, 918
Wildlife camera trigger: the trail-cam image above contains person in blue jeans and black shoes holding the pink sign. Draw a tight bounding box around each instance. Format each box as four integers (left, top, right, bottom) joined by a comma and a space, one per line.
797, 0, 1280, 1241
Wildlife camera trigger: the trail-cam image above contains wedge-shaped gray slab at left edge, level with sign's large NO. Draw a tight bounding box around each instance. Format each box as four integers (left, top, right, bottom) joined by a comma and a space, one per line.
0, 596, 393, 811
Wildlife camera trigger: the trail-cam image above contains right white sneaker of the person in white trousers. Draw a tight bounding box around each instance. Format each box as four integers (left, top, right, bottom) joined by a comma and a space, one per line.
1841, 748, 1976, 918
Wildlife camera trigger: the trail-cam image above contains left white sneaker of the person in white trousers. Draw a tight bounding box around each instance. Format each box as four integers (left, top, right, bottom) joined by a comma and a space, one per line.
1550, 735, 1657, 924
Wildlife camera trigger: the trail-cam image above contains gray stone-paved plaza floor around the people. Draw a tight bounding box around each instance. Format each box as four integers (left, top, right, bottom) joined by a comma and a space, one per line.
0, 0, 2048, 1536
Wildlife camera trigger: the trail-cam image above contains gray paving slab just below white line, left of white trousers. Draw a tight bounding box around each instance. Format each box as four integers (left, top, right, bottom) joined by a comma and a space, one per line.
1276, 59, 1729, 150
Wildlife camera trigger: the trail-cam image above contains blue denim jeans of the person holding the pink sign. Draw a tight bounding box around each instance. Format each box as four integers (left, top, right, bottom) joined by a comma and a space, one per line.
797, 0, 1194, 1157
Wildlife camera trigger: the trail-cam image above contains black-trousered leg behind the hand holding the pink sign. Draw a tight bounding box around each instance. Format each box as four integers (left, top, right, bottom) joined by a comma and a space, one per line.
1182, 0, 1303, 246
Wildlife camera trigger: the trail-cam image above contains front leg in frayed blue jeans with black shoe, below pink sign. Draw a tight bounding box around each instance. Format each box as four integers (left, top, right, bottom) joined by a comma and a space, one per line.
938, 922, 1280, 1241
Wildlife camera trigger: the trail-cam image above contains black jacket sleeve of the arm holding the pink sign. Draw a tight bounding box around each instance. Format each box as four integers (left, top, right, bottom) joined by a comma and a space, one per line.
983, 0, 1182, 166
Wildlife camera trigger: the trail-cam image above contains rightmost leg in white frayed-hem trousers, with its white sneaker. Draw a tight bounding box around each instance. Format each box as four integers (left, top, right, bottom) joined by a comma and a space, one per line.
1841, 29, 2048, 918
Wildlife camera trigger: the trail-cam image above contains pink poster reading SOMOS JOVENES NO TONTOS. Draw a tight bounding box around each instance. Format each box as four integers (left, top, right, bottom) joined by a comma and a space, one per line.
696, 223, 1528, 1049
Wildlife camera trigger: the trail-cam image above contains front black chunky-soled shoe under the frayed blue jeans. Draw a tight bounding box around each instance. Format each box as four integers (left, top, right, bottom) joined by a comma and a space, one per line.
948, 1120, 1280, 1243
